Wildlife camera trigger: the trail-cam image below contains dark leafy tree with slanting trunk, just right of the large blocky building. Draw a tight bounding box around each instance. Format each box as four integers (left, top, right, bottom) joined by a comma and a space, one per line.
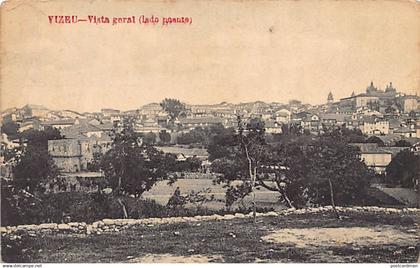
101, 123, 176, 217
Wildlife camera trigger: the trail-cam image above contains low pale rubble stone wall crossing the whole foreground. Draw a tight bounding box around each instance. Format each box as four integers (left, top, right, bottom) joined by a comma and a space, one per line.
0, 206, 420, 236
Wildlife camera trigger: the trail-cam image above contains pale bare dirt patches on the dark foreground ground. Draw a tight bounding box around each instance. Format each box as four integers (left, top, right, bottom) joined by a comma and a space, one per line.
124, 226, 419, 263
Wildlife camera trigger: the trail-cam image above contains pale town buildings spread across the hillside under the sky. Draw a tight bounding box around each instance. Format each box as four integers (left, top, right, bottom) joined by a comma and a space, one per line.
1, 82, 420, 181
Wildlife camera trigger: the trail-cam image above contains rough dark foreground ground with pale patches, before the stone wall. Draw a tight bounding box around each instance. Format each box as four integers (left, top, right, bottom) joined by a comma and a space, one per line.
10, 212, 420, 263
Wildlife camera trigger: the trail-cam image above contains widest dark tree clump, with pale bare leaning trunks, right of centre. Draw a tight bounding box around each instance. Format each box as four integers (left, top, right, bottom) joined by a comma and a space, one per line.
209, 122, 372, 219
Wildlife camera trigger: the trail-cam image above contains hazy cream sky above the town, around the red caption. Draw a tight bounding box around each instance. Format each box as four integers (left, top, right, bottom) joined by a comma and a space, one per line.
0, 0, 420, 111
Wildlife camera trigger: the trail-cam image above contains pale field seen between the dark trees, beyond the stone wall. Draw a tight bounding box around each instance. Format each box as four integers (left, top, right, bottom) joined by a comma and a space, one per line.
142, 179, 284, 210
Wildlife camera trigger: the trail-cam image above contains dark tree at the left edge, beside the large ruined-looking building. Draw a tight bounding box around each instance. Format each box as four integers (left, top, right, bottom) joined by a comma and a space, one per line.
1, 129, 61, 228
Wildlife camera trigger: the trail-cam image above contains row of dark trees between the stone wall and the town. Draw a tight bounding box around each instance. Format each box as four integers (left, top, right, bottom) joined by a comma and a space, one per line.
2, 112, 420, 225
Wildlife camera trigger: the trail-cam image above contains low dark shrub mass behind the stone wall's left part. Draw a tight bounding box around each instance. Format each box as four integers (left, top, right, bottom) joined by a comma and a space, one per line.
1, 192, 170, 226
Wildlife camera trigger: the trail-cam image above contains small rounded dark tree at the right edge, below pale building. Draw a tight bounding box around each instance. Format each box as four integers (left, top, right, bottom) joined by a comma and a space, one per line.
386, 150, 420, 188
